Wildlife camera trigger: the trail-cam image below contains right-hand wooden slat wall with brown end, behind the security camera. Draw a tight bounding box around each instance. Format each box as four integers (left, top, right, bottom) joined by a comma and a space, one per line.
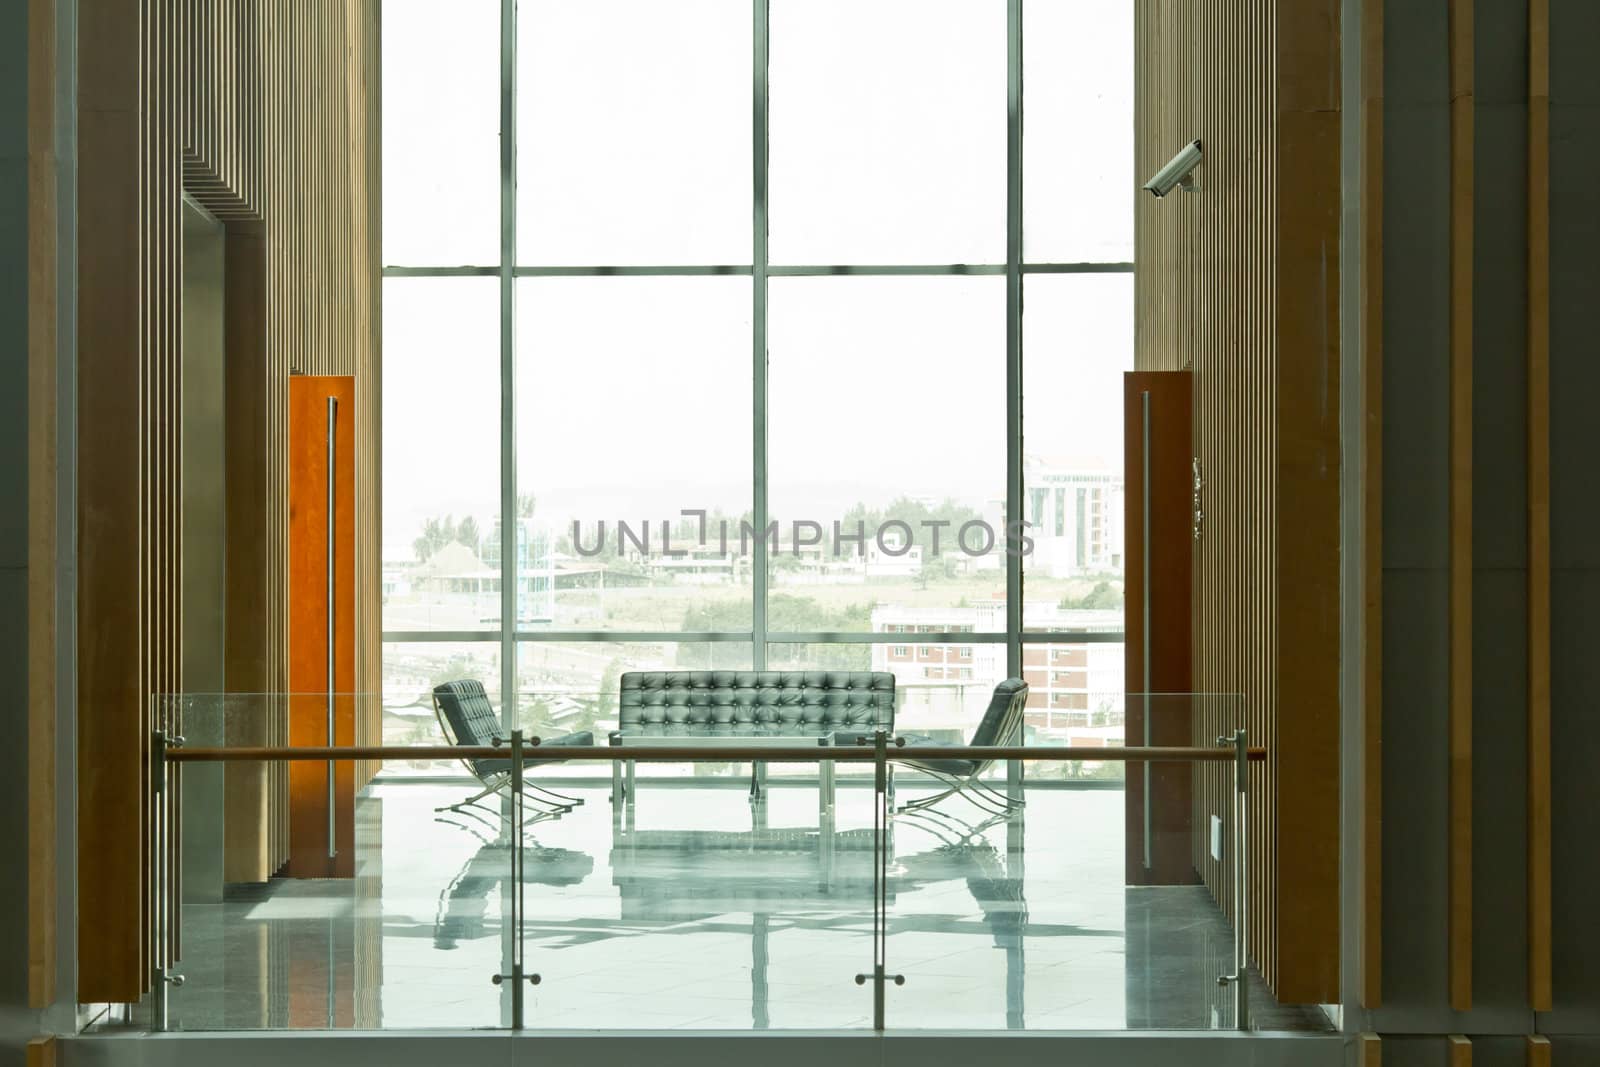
1136, 0, 1339, 1001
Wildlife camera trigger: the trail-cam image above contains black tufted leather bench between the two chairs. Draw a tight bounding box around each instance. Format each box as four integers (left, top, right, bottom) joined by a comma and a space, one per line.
611, 670, 894, 806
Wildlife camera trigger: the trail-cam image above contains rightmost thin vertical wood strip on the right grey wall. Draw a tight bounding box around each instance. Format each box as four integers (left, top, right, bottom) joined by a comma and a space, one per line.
1528, 0, 1554, 1017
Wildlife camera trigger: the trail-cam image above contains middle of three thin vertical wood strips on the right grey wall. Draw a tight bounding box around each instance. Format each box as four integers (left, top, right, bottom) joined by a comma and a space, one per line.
1448, 0, 1474, 1011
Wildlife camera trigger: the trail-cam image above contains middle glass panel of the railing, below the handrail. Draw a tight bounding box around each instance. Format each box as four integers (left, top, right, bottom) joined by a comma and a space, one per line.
525, 765, 877, 1030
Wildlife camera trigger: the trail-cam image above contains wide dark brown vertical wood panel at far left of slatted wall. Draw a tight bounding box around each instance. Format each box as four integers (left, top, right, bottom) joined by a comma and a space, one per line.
77, 0, 147, 1001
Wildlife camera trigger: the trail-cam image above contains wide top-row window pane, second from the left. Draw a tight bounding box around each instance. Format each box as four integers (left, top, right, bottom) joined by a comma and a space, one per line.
517, 0, 754, 264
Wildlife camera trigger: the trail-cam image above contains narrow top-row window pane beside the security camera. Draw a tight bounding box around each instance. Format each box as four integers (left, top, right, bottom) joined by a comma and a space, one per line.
1022, 0, 1139, 262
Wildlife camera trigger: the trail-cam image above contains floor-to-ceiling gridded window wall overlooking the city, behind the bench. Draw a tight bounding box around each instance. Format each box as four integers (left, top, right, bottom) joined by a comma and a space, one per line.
382, 0, 1136, 758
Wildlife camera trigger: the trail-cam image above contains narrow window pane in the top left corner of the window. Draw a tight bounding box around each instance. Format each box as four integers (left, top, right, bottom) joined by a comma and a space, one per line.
382, 0, 499, 266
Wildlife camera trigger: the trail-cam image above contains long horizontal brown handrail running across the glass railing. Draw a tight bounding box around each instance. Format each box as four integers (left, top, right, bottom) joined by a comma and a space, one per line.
166, 739, 1267, 763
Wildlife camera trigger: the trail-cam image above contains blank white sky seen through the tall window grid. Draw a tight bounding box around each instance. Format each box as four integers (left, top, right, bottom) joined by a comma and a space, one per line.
382, 0, 1136, 558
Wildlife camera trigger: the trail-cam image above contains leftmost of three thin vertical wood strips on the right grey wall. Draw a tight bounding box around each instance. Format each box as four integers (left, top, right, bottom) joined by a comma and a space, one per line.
1360, 0, 1384, 1009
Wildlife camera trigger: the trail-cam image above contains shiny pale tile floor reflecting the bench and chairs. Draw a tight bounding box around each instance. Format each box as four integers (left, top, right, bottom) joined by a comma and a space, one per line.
171, 782, 1328, 1030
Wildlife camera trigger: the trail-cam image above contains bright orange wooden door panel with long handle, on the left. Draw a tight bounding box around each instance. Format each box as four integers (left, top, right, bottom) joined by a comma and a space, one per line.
285, 374, 355, 878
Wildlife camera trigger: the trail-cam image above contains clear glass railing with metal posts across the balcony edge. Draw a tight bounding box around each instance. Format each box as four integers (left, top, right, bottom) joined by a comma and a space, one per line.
140, 691, 1325, 1030
